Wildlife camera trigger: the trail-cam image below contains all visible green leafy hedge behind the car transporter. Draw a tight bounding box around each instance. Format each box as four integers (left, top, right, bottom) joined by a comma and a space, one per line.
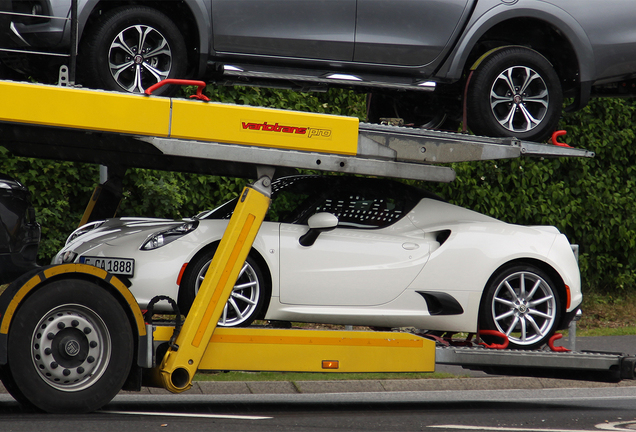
0, 87, 636, 291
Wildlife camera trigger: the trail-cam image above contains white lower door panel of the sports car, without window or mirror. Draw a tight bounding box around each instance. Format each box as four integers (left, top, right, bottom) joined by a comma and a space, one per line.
280, 224, 429, 306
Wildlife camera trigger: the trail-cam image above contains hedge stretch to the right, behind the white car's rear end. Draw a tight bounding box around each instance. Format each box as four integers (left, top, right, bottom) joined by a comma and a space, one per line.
434, 99, 636, 292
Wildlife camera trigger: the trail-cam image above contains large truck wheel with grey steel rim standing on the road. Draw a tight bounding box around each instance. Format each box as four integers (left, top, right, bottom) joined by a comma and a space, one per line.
3, 280, 134, 413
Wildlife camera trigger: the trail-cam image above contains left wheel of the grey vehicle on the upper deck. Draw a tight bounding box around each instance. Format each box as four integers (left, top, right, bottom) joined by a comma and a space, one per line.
78, 6, 188, 95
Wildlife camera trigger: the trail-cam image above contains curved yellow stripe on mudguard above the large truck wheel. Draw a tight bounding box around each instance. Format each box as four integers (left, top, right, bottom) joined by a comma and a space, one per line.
0, 264, 146, 336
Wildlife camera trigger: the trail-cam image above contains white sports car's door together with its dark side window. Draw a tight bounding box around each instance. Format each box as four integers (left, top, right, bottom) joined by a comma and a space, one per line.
276, 183, 429, 306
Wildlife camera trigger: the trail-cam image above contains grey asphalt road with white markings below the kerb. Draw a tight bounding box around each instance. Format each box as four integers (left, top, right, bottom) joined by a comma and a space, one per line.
0, 387, 636, 432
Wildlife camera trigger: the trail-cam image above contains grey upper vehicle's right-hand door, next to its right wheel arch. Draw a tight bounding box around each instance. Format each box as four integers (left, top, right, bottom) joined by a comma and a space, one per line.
354, 0, 476, 66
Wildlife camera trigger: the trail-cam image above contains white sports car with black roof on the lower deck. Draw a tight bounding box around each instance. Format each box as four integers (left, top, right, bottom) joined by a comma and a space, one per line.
53, 176, 582, 349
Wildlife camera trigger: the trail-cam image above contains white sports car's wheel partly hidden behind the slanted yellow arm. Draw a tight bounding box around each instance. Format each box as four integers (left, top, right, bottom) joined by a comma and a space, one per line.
178, 247, 271, 327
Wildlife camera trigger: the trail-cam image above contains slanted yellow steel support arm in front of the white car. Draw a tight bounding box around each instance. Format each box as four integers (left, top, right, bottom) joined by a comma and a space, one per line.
157, 187, 270, 393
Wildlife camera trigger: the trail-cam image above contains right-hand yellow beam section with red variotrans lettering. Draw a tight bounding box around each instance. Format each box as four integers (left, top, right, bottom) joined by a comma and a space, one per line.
170, 99, 359, 155
